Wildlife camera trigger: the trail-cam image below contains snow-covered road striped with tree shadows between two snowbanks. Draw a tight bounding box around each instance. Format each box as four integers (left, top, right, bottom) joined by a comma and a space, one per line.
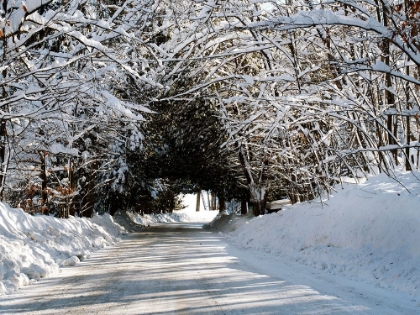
0, 224, 419, 315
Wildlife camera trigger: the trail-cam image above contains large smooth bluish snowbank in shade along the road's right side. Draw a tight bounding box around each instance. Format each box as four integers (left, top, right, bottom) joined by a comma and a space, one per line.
227, 172, 420, 296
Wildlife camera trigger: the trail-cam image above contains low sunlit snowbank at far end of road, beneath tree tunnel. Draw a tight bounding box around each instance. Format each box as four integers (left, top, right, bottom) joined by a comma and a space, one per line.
127, 210, 218, 226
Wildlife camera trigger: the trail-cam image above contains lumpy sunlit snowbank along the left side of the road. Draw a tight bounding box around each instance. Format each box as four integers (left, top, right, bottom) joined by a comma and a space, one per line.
0, 203, 125, 295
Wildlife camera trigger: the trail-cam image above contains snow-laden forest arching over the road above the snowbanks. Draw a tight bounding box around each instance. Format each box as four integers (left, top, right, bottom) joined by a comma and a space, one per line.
0, 0, 420, 217
